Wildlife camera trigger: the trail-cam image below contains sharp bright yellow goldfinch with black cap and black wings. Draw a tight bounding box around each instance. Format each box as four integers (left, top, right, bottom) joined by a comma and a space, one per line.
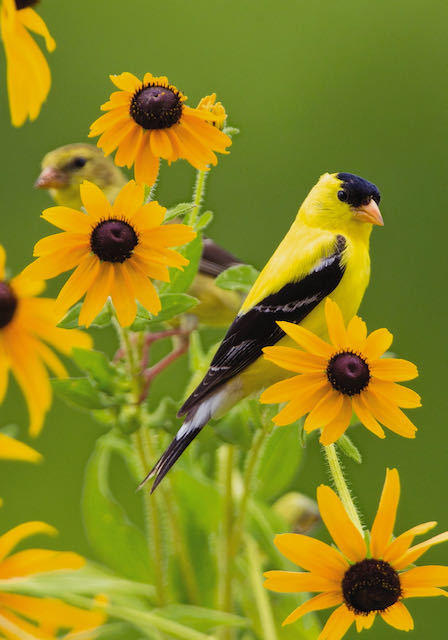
142, 173, 384, 491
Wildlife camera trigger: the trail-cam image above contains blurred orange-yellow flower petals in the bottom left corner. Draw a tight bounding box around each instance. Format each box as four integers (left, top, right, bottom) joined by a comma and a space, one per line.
0, 522, 105, 640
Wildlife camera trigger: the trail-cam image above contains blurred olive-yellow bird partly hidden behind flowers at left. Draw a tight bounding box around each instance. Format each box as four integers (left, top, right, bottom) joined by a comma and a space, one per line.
35, 143, 241, 327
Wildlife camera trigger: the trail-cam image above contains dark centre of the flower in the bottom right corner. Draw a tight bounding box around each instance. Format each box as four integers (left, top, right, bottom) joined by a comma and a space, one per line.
342, 558, 401, 614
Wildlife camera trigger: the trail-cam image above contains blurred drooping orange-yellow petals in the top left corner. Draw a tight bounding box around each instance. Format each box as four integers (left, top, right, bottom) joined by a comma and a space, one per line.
0, 0, 56, 127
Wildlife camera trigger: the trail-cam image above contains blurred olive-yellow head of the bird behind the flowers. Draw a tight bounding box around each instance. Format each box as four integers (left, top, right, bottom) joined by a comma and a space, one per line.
34, 143, 126, 208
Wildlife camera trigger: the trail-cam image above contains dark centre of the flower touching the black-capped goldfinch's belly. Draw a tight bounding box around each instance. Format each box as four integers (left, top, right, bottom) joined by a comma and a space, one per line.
327, 351, 370, 396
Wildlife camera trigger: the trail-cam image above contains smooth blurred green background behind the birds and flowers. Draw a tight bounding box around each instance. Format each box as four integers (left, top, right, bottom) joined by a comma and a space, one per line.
0, 0, 448, 640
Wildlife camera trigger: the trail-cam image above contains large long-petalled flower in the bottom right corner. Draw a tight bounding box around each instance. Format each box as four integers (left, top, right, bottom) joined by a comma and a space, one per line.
264, 469, 448, 640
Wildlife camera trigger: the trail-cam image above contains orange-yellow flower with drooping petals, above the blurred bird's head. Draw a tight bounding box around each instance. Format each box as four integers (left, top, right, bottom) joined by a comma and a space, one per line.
89, 73, 232, 185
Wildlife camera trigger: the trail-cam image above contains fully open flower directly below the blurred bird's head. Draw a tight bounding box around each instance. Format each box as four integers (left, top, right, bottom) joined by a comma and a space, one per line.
25, 180, 196, 326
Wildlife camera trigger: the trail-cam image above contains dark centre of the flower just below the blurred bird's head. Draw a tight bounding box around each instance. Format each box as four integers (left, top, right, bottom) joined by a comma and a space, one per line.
90, 219, 138, 262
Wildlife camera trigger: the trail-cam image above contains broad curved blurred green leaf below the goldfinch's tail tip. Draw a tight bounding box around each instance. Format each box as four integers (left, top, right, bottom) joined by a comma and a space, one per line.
82, 436, 153, 582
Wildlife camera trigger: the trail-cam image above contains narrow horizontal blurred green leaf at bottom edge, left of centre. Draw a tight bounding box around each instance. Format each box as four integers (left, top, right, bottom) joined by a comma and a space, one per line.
154, 604, 249, 632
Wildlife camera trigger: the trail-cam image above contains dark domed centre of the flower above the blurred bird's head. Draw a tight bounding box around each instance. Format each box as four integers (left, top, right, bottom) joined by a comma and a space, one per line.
129, 86, 182, 129
